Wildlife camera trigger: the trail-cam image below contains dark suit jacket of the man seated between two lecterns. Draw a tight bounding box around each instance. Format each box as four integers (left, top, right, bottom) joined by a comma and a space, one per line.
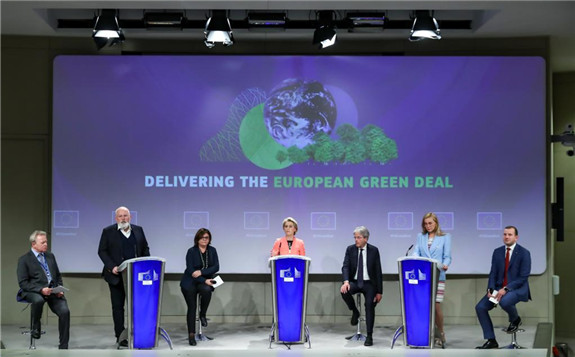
341, 243, 383, 294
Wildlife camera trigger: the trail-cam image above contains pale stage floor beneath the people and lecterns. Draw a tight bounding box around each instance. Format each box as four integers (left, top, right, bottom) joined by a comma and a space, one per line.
0, 323, 547, 357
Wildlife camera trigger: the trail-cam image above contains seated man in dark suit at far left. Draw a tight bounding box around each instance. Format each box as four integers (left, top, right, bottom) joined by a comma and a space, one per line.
18, 231, 70, 349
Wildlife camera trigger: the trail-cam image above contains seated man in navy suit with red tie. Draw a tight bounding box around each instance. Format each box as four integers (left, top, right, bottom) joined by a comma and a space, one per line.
475, 226, 531, 349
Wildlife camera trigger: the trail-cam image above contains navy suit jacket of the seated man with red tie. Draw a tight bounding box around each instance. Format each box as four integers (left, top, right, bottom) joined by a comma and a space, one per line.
487, 244, 531, 301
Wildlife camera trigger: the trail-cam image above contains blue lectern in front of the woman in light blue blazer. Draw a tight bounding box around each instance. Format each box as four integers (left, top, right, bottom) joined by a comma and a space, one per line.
396, 257, 438, 348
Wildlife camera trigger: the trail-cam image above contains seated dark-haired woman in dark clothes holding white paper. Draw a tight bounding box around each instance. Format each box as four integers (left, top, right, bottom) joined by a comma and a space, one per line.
180, 228, 220, 346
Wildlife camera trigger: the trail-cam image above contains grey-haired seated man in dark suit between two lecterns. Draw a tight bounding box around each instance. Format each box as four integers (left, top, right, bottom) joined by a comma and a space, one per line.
340, 226, 383, 346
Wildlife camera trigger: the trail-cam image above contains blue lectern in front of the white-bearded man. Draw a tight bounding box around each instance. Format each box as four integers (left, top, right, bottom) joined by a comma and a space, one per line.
118, 257, 166, 348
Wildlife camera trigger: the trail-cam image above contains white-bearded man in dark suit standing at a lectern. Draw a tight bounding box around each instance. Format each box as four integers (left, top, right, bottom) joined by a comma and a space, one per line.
98, 207, 150, 346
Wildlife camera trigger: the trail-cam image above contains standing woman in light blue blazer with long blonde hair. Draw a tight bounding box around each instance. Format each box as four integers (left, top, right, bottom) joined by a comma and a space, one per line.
413, 212, 451, 347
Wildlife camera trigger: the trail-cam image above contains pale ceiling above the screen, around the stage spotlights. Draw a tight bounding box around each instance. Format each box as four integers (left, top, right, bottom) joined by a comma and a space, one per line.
1, 0, 575, 72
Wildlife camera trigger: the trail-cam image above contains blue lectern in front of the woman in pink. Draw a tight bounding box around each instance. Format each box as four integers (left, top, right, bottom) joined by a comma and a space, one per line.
269, 255, 311, 347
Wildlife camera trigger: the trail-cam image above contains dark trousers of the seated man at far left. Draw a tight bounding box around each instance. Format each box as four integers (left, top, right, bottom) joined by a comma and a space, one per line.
23, 292, 70, 348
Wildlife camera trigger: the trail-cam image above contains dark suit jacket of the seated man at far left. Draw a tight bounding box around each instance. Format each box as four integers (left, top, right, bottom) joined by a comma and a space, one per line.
17, 250, 62, 298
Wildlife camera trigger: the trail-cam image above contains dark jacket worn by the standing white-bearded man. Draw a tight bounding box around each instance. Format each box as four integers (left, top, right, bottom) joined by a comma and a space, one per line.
98, 224, 150, 285
